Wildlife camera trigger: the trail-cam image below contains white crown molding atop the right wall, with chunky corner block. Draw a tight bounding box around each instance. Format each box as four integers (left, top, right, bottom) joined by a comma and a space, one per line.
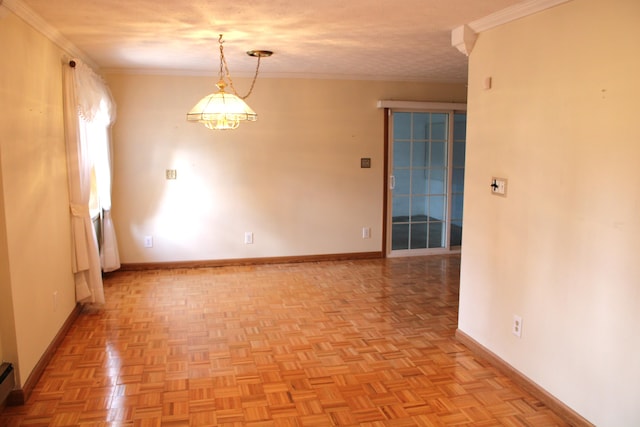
451, 0, 571, 56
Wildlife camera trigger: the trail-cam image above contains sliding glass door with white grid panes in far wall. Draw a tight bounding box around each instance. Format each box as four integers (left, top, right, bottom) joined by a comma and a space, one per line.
387, 111, 466, 255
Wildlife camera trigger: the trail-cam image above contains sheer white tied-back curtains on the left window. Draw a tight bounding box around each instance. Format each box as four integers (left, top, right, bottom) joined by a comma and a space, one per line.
63, 59, 119, 304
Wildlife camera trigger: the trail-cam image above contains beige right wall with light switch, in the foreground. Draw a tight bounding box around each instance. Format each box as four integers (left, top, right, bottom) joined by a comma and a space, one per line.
459, 0, 640, 426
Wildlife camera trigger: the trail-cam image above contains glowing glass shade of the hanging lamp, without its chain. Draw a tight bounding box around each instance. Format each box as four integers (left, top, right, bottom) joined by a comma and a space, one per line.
187, 85, 258, 129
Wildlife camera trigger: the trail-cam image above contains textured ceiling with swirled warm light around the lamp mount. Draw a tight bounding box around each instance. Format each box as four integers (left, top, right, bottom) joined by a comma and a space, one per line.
22, 0, 522, 82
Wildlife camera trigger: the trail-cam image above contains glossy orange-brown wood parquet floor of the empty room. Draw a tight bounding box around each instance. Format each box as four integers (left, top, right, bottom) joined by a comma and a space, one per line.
0, 255, 566, 427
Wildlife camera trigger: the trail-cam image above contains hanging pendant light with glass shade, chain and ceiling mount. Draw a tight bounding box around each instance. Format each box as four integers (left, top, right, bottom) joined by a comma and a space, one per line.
187, 34, 273, 129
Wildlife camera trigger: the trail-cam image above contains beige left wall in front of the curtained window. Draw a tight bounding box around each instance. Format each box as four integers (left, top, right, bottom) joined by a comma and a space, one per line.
0, 6, 75, 384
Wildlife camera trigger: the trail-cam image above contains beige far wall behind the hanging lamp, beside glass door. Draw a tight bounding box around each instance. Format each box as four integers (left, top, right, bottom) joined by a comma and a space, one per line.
107, 74, 466, 263
